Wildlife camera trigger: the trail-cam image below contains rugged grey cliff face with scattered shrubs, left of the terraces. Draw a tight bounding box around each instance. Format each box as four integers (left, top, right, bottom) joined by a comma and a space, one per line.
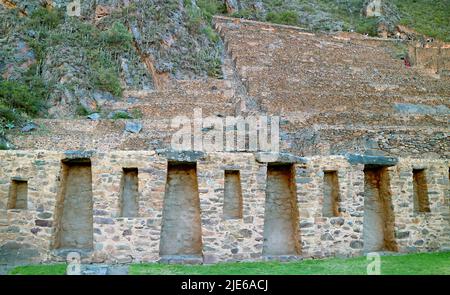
0, 0, 222, 117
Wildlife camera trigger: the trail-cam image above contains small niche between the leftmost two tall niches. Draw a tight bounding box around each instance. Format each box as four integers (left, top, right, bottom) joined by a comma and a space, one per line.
120, 168, 139, 217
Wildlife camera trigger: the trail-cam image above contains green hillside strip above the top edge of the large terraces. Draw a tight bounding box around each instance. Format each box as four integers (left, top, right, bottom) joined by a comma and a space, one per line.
232, 0, 450, 41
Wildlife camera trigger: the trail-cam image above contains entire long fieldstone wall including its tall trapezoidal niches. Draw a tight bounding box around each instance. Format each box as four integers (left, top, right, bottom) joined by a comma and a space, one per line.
0, 151, 450, 263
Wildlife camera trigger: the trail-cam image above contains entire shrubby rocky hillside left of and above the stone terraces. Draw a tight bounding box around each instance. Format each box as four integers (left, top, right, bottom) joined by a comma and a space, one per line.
0, 0, 450, 148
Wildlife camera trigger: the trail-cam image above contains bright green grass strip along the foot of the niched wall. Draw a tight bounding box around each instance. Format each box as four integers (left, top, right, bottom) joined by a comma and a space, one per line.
10, 252, 450, 275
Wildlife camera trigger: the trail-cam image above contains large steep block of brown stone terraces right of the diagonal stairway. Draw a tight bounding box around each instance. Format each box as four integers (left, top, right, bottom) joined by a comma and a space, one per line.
215, 17, 450, 158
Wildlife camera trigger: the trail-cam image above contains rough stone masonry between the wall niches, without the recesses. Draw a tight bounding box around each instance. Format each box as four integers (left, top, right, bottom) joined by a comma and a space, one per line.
0, 151, 450, 264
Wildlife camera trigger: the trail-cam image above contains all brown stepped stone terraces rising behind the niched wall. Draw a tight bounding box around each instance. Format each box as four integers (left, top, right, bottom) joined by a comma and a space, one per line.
7, 17, 450, 158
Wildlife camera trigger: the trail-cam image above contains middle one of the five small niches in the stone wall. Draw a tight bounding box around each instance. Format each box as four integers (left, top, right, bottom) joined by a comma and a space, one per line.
223, 170, 242, 219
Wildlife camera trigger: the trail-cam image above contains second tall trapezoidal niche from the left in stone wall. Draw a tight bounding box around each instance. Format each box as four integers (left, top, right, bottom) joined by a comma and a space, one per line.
160, 162, 202, 258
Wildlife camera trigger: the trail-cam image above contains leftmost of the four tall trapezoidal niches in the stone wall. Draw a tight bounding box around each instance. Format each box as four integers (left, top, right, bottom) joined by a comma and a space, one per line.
54, 159, 93, 249
